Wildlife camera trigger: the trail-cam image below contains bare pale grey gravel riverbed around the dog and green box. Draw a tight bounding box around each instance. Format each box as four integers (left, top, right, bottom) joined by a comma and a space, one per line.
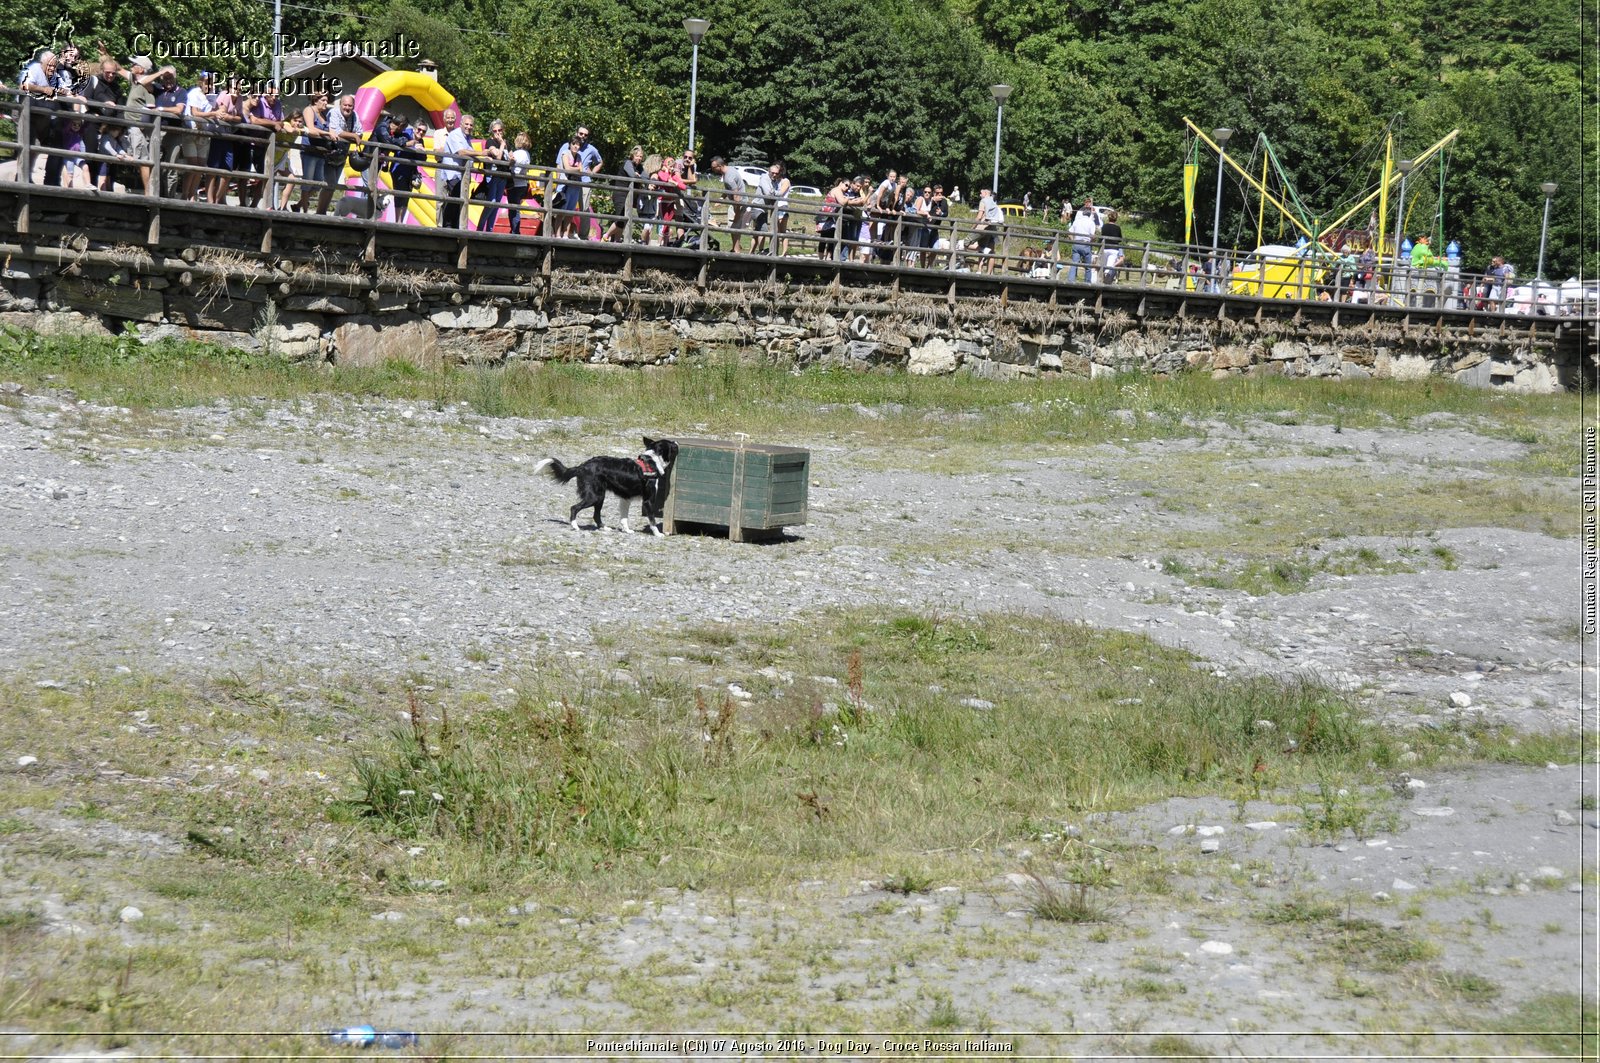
0, 384, 1597, 1055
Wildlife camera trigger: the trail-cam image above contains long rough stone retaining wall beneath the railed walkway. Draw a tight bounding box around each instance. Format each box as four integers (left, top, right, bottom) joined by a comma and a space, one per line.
0, 248, 1592, 391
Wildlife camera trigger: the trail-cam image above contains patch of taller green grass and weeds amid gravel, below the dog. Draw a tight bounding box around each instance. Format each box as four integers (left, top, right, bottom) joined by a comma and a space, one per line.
354, 610, 1484, 887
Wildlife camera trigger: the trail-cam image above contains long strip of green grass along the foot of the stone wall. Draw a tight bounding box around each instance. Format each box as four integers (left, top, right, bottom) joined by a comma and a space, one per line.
0, 331, 1578, 475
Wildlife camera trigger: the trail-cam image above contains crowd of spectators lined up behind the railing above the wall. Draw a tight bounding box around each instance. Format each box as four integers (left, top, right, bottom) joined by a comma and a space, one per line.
9, 45, 1548, 309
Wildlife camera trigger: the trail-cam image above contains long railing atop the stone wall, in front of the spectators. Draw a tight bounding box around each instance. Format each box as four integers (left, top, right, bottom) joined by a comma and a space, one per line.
0, 90, 1595, 314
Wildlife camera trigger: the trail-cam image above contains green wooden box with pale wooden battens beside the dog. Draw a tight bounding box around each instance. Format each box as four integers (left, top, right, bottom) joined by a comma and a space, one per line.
662, 439, 811, 543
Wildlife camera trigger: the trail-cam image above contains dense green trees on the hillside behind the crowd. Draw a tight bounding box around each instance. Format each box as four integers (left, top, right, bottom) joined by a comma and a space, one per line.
0, 0, 1600, 277
